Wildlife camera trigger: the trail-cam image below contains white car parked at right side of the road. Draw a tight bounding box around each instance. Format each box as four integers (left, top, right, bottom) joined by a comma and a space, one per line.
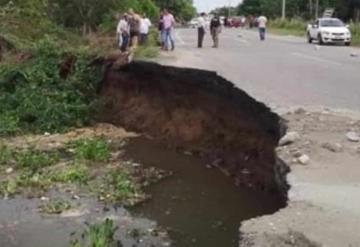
307, 18, 351, 46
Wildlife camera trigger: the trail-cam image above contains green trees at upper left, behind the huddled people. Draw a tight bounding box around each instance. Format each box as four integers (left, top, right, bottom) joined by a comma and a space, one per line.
0, 0, 196, 33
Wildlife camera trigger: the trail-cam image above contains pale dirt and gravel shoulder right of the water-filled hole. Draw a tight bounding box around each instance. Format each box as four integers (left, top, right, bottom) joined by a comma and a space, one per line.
240, 109, 360, 247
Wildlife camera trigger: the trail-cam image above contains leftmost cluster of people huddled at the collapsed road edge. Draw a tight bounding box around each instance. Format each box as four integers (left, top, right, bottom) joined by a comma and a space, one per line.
116, 9, 152, 52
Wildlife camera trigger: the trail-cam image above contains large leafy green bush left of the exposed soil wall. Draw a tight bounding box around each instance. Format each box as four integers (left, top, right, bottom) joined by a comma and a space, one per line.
0, 37, 102, 136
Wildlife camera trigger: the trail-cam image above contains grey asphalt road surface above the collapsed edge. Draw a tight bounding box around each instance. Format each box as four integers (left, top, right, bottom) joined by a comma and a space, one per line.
160, 29, 360, 111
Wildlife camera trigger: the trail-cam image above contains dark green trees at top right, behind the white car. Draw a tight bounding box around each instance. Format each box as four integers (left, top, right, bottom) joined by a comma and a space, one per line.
236, 0, 360, 22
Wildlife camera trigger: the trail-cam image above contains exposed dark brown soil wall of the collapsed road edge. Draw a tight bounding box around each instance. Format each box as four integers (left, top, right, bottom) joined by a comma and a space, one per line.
99, 62, 284, 195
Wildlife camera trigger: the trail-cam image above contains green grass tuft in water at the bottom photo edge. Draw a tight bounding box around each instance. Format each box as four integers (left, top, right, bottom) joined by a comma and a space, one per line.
70, 219, 122, 247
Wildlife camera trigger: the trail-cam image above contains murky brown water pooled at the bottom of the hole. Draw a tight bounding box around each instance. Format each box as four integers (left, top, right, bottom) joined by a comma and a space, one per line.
126, 138, 284, 247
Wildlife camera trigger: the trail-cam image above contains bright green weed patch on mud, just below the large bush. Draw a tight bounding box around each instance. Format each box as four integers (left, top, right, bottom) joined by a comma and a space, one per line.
67, 138, 111, 161
